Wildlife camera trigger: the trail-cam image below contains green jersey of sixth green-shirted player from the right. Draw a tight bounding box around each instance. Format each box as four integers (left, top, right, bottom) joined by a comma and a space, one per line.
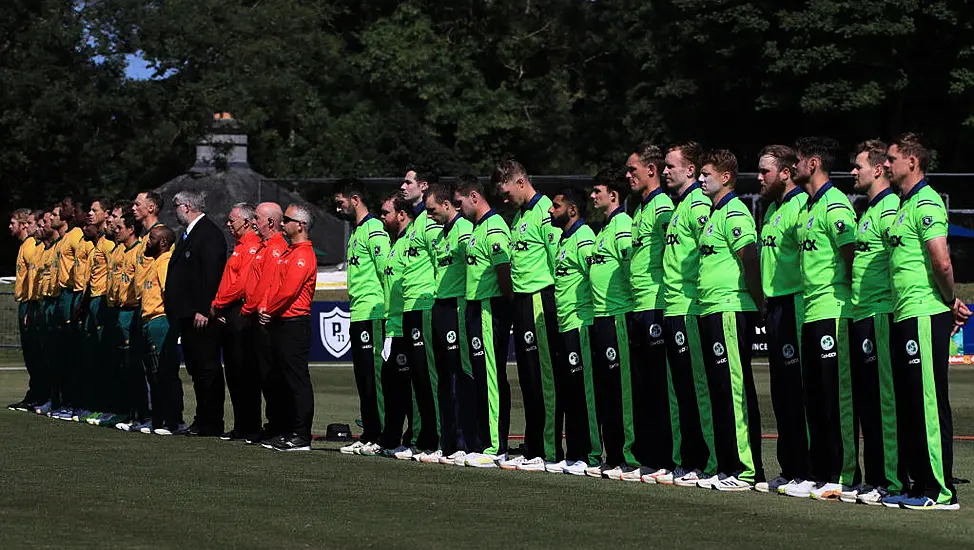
663, 183, 710, 317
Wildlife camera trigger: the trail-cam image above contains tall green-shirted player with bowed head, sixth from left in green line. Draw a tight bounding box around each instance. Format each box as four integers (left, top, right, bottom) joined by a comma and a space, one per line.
491, 160, 564, 472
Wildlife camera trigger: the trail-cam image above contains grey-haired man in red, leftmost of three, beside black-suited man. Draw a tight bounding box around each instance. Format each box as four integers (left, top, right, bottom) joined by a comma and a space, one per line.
210, 202, 261, 441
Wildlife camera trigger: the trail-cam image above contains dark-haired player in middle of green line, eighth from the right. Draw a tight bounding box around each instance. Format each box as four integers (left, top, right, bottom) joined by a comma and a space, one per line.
585, 170, 640, 480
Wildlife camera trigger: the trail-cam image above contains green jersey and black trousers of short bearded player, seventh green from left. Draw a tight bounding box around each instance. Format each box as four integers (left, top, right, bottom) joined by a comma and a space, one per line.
555, 220, 602, 466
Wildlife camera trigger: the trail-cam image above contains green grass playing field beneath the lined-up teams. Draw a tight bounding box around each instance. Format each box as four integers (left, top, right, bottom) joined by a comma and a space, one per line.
0, 366, 974, 549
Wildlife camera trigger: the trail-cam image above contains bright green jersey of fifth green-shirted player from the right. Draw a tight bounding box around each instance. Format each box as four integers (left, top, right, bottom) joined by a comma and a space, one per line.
698, 192, 758, 315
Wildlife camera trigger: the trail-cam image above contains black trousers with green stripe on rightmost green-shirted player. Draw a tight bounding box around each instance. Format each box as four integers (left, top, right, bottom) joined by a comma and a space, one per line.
893, 311, 957, 504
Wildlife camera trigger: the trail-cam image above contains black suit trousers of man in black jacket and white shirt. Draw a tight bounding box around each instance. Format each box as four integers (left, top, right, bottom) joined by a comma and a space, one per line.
179, 317, 225, 435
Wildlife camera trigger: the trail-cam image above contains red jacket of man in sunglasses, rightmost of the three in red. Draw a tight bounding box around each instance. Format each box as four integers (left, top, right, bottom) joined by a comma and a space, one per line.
260, 241, 318, 319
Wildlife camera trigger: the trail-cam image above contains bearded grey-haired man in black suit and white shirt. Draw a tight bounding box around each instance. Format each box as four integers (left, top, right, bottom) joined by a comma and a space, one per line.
165, 191, 227, 436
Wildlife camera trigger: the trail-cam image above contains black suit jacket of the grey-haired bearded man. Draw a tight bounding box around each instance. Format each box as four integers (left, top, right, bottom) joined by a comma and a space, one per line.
163, 216, 227, 319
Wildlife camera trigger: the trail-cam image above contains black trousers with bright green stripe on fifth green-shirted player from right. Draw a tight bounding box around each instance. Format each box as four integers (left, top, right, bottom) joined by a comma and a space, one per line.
700, 312, 764, 483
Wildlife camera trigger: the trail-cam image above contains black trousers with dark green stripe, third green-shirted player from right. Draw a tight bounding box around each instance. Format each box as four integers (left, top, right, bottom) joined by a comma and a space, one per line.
802, 319, 862, 486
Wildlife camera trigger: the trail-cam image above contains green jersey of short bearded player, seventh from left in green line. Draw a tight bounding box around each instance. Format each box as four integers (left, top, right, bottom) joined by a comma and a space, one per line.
555, 220, 595, 332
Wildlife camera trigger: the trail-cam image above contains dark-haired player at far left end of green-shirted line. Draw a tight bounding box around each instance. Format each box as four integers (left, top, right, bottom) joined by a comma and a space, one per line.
334, 180, 390, 455
